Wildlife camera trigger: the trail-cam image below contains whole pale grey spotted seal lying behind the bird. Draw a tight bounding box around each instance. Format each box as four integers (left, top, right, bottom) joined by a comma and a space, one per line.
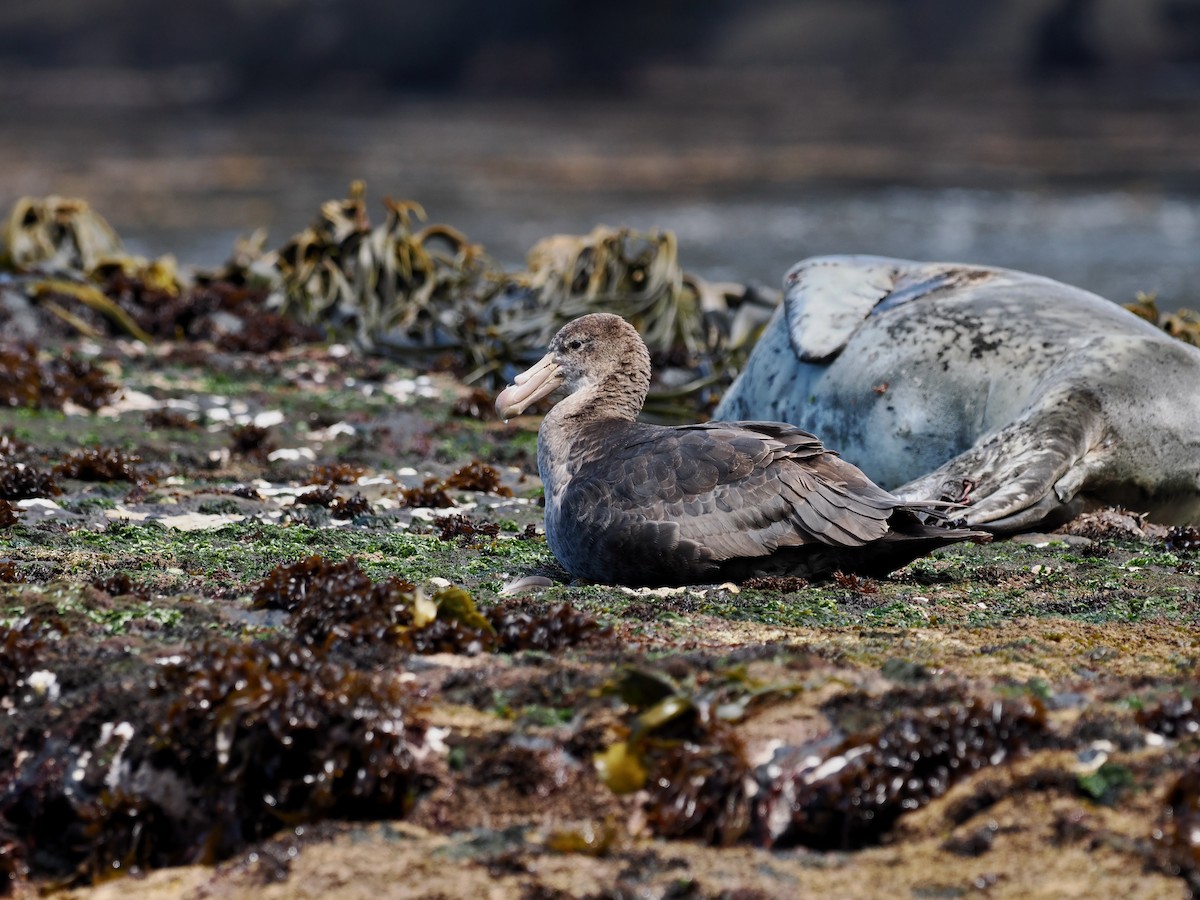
715, 257, 1200, 532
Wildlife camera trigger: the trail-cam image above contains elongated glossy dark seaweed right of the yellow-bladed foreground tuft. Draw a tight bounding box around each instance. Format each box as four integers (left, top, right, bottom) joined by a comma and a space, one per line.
755, 698, 1046, 850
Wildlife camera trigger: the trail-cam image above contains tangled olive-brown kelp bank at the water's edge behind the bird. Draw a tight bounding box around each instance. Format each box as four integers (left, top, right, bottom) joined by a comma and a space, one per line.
5, 189, 779, 418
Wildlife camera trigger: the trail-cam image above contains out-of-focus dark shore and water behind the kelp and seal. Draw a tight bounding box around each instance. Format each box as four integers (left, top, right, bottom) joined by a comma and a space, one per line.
0, 0, 1200, 308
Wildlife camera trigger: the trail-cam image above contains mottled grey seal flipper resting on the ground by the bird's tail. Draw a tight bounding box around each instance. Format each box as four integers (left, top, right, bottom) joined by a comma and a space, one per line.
894, 389, 1104, 533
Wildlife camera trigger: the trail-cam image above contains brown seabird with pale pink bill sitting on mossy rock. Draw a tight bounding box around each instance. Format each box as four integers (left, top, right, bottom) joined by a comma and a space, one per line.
496, 313, 988, 584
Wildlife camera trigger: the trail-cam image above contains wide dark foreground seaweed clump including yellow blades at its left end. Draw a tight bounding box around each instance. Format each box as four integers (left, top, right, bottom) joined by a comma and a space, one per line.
596, 671, 1046, 850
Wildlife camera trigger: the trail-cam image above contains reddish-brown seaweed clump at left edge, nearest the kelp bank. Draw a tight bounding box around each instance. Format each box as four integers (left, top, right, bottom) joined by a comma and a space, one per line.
0, 343, 118, 410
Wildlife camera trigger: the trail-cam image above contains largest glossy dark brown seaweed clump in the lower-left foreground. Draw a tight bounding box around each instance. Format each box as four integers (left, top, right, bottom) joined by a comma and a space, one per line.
148, 643, 425, 858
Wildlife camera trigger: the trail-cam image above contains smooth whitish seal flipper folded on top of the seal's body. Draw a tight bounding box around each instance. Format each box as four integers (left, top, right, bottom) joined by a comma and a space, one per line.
784, 256, 997, 364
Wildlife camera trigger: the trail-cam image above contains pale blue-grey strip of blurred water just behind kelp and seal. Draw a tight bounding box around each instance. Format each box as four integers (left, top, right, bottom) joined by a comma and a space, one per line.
114, 188, 1200, 308
